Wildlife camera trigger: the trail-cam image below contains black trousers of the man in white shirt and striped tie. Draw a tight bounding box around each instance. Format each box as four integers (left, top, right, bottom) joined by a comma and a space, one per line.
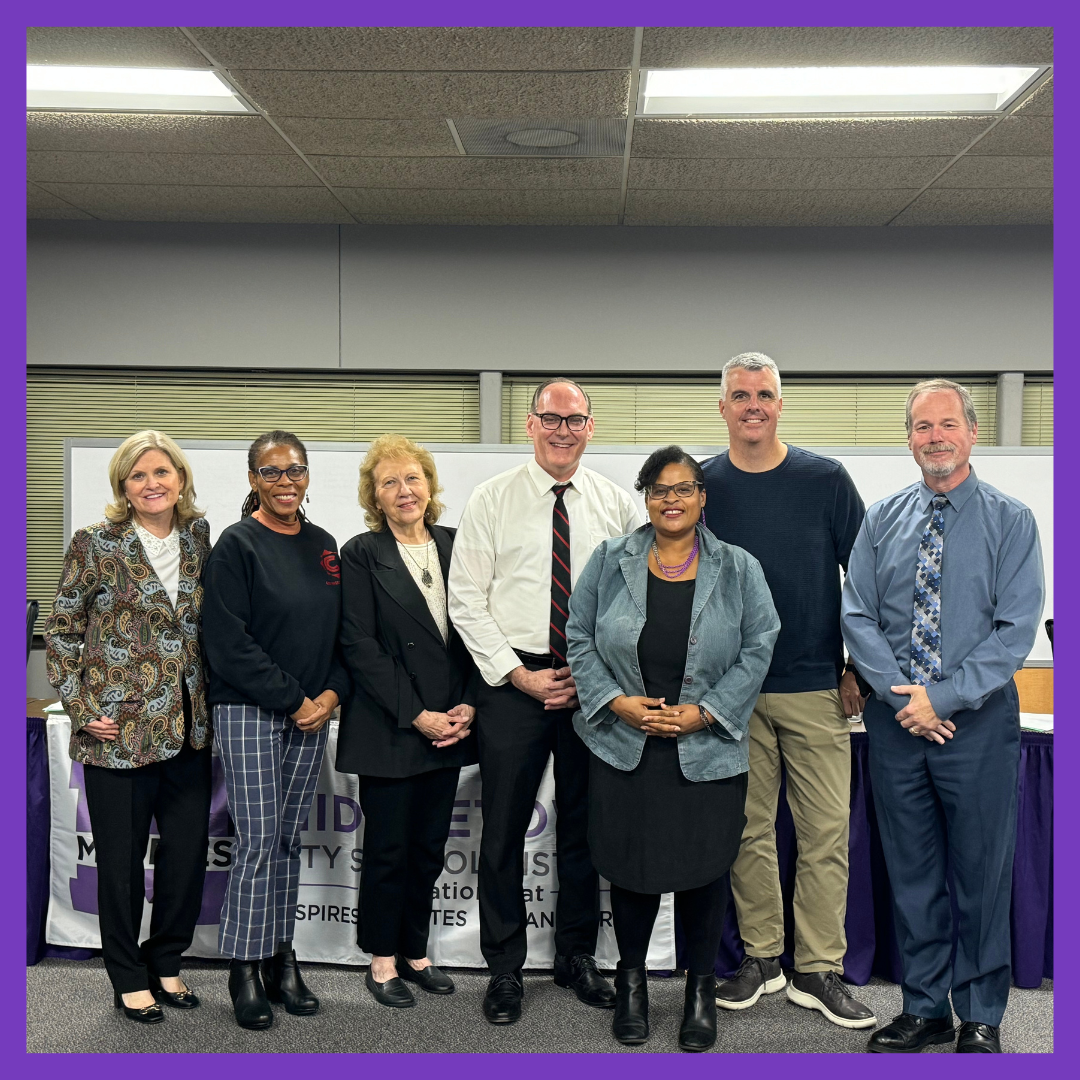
476, 684, 600, 975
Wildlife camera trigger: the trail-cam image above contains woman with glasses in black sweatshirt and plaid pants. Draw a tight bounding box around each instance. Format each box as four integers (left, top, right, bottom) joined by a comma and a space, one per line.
203, 431, 349, 1029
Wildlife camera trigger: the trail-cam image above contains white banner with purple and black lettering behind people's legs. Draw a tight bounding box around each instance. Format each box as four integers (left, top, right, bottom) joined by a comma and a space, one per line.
45, 714, 675, 970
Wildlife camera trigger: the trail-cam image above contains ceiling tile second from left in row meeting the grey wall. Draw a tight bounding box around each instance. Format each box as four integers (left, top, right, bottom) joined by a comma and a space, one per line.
33, 184, 352, 224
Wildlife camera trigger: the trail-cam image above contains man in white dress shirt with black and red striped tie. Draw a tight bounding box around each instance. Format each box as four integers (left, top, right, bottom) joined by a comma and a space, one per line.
447, 378, 642, 1024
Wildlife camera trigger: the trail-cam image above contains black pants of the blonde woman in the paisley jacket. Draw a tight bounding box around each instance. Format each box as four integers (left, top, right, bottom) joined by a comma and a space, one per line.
83, 741, 211, 994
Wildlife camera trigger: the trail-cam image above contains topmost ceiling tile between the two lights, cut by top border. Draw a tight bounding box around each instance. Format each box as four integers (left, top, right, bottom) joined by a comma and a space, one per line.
190, 26, 634, 71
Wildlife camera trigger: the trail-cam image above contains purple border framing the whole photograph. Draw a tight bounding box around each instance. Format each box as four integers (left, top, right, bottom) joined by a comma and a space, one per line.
12, 0, 1067, 1077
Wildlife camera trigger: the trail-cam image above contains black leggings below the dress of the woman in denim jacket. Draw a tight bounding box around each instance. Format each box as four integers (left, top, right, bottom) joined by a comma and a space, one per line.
611, 874, 729, 975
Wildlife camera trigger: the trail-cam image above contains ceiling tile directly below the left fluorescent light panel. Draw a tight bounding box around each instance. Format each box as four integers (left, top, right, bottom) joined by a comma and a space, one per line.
26, 112, 288, 153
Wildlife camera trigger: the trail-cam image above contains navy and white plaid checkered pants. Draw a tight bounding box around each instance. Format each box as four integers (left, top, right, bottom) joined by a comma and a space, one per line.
214, 705, 326, 960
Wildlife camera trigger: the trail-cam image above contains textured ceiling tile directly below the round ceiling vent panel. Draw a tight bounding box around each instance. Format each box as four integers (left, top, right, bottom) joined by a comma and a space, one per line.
311, 156, 622, 190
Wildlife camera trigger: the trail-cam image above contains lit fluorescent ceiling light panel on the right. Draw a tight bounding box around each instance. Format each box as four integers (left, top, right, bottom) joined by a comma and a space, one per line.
637, 67, 1047, 117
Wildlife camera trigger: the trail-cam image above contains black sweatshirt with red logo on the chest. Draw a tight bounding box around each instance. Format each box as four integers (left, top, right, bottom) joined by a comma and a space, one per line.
202, 517, 349, 714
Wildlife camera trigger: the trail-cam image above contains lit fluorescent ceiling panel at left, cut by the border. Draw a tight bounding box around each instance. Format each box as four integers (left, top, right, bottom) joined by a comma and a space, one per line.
26, 64, 255, 112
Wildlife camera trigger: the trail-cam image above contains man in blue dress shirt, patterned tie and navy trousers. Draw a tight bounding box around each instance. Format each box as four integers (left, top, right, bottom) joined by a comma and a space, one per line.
841, 379, 1043, 1053
